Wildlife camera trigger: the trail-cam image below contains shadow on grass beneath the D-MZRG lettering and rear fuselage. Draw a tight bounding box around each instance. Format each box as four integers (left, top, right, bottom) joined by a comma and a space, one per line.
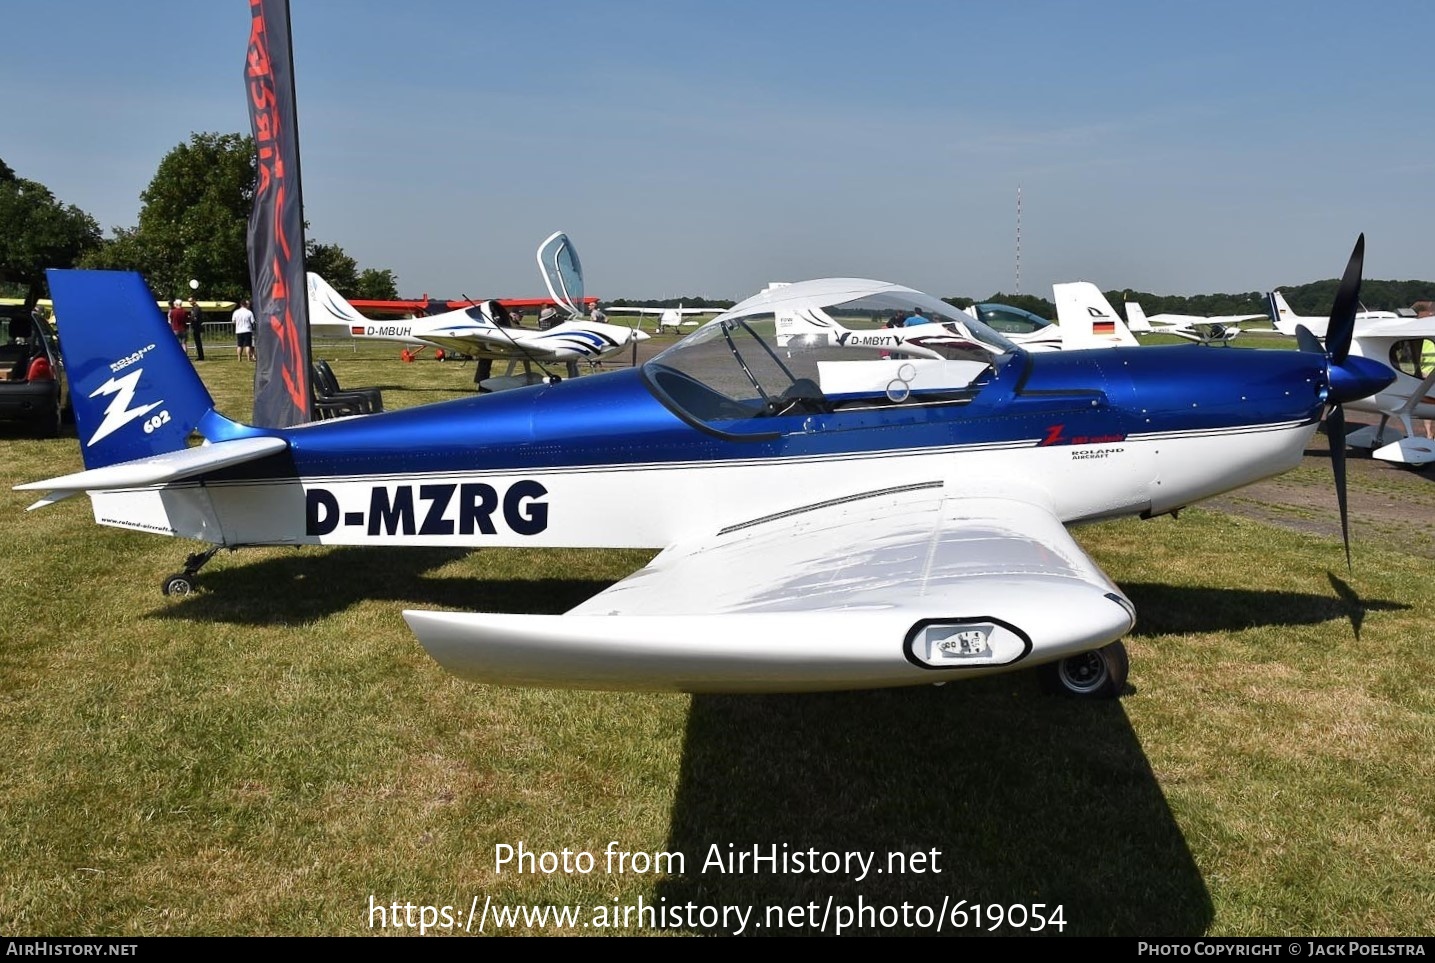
149, 547, 611, 626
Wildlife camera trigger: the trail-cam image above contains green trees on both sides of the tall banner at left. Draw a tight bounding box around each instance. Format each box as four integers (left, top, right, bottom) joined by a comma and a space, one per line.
0, 133, 399, 307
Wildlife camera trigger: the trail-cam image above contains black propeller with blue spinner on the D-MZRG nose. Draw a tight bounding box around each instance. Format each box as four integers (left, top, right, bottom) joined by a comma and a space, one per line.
1296, 234, 1395, 568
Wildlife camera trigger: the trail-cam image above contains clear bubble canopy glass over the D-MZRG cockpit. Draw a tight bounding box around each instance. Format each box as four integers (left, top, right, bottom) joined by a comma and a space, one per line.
643, 283, 1020, 432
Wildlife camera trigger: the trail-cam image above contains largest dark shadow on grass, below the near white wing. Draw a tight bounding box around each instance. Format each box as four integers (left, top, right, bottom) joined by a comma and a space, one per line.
657, 672, 1213, 936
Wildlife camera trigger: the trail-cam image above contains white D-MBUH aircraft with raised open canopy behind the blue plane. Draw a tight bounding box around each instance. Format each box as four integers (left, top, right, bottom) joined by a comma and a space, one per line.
309, 231, 649, 390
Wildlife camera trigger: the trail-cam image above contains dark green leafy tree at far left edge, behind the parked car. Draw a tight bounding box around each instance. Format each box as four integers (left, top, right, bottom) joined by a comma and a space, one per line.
0, 161, 100, 309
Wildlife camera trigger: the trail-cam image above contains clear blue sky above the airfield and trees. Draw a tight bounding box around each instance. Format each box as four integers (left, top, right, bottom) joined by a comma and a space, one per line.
0, 0, 1435, 299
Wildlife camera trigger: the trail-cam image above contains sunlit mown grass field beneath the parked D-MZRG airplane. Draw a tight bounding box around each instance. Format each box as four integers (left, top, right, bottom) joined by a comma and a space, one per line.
0, 344, 1435, 936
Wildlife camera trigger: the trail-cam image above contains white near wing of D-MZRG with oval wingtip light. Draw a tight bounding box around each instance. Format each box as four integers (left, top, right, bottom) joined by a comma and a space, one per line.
403, 482, 1134, 692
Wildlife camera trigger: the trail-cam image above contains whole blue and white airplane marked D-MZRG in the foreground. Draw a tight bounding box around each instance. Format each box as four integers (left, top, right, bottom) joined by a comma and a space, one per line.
20, 238, 1392, 696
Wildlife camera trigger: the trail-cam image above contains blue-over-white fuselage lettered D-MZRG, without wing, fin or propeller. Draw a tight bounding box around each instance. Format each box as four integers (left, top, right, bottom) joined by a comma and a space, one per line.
92, 346, 1325, 548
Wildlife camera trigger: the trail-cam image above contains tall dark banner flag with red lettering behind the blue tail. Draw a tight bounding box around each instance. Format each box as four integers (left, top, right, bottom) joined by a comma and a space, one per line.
244, 0, 313, 428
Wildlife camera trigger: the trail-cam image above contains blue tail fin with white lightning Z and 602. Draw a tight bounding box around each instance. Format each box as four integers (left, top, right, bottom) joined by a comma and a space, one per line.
46, 270, 214, 468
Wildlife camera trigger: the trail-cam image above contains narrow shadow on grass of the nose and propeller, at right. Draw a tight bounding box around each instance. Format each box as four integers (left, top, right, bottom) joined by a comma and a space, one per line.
1121, 576, 1409, 639
